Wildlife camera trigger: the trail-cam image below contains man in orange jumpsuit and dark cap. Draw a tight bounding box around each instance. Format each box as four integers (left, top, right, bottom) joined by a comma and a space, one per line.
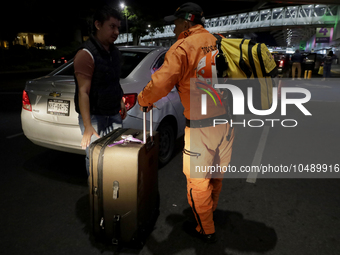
138, 3, 234, 243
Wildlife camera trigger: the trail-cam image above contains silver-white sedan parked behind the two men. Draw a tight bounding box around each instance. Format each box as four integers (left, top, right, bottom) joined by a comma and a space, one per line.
21, 46, 185, 164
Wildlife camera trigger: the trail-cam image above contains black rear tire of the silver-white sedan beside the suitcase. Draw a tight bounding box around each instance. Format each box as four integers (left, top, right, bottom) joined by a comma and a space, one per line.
157, 122, 176, 166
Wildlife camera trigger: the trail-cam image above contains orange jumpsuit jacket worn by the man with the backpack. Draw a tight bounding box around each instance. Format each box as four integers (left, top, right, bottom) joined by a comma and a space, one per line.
138, 25, 225, 120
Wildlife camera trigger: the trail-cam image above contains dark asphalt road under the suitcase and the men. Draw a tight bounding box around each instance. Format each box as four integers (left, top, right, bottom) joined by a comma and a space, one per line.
0, 70, 340, 255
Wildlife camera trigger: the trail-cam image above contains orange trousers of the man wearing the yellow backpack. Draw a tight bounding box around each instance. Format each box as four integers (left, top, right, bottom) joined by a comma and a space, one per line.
183, 124, 234, 235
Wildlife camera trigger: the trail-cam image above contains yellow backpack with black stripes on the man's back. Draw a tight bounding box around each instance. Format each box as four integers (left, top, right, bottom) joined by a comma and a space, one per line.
214, 34, 277, 110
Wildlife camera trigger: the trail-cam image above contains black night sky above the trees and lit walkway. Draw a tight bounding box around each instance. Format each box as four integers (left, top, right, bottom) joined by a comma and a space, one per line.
0, 0, 278, 45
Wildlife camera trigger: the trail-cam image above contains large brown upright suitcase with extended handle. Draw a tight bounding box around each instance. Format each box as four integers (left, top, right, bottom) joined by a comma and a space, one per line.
89, 110, 159, 248
